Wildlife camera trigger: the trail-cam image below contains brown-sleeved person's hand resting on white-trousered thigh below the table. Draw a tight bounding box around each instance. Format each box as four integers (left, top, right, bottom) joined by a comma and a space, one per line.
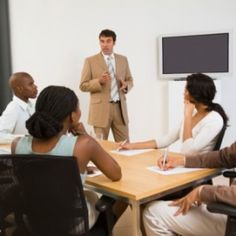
169, 186, 202, 216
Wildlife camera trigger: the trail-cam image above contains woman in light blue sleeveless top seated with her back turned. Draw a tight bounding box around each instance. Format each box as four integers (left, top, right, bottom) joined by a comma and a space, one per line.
12, 86, 121, 228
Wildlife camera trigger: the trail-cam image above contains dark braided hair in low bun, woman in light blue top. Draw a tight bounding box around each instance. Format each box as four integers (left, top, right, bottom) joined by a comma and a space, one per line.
26, 86, 79, 139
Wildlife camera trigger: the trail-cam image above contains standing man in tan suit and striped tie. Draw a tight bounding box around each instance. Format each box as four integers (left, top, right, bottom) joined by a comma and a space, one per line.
80, 29, 133, 142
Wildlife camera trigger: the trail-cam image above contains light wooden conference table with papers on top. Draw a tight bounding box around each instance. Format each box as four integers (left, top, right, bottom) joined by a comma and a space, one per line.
86, 141, 221, 236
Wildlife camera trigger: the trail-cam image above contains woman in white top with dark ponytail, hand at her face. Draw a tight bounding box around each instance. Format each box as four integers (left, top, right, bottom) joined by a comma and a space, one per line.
120, 73, 228, 154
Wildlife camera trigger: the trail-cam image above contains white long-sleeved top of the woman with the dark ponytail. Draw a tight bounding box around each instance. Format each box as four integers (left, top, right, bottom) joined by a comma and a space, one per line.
156, 111, 223, 155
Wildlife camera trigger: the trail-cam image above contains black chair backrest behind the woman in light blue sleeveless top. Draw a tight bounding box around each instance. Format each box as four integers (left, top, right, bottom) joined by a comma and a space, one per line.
3, 155, 88, 236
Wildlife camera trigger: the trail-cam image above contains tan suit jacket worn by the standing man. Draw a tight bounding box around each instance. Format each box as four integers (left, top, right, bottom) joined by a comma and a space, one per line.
80, 53, 133, 128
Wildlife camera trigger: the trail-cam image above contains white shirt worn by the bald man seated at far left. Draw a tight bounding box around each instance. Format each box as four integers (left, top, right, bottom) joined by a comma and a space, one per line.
0, 96, 34, 138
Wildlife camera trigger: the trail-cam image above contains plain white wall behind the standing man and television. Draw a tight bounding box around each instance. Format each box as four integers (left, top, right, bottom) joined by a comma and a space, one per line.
10, 0, 236, 145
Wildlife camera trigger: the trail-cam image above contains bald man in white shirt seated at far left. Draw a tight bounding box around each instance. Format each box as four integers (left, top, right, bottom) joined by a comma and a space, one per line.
0, 72, 38, 139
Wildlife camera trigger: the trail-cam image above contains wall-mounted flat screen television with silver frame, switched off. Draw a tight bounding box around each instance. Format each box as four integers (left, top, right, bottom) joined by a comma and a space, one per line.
159, 32, 231, 79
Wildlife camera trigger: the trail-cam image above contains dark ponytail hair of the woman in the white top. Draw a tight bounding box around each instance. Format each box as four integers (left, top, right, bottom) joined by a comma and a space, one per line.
186, 73, 229, 126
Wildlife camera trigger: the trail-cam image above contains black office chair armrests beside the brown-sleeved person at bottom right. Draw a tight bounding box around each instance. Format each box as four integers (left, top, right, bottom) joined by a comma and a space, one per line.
207, 171, 236, 236
